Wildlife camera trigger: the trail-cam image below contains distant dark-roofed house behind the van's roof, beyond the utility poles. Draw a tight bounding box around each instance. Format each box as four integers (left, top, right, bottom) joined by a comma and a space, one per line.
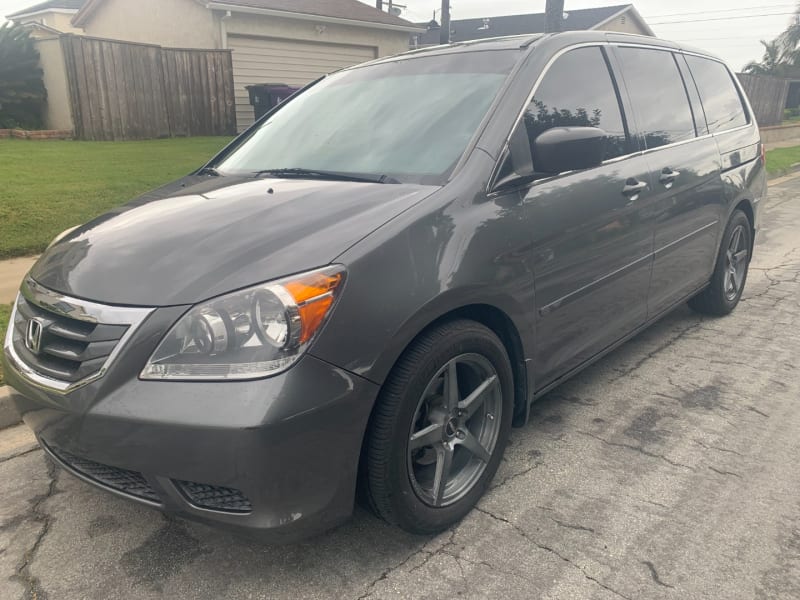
411, 4, 655, 48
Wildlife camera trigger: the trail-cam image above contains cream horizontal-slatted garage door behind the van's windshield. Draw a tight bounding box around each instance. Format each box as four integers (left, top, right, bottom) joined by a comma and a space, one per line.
228, 35, 376, 131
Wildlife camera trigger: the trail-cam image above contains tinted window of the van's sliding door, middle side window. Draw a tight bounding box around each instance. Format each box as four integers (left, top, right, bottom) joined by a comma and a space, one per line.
618, 48, 695, 148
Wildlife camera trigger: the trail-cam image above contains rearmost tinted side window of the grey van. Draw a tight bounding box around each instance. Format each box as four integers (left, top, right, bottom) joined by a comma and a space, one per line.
686, 56, 747, 133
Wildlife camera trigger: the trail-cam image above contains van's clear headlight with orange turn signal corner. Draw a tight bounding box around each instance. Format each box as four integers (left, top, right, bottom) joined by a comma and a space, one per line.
141, 267, 344, 381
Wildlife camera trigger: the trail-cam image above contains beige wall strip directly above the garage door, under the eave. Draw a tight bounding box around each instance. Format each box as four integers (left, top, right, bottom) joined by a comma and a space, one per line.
225, 13, 409, 58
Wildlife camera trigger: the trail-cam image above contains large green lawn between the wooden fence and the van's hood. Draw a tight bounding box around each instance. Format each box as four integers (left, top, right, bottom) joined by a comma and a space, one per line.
0, 137, 230, 259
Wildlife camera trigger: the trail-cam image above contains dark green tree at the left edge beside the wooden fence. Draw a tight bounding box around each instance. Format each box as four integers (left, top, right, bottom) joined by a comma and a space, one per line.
0, 23, 47, 128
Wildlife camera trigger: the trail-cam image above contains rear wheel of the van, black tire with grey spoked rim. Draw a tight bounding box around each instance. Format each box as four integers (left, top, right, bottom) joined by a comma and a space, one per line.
689, 210, 753, 317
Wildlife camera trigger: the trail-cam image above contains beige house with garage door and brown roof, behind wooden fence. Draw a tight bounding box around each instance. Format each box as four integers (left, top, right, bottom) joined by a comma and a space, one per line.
67, 0, 424, 131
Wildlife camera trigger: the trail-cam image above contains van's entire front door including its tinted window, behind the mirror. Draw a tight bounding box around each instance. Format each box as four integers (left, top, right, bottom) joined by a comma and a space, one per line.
500, 47, 654, 389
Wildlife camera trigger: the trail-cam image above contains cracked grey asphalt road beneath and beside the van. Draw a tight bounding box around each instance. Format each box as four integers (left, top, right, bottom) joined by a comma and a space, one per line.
0, 179, 800, 600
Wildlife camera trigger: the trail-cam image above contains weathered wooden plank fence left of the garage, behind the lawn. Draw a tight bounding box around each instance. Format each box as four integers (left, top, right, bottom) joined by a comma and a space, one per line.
61, 35, 236, 140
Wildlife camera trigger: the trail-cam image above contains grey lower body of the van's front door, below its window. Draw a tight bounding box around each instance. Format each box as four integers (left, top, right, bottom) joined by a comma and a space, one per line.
525, 156, 653, 385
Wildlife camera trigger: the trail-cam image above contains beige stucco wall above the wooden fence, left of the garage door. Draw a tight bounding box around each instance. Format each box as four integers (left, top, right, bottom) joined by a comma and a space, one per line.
85, 0, 221, 49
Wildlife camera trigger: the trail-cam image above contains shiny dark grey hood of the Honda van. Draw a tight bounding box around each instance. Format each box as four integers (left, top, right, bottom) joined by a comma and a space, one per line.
31, 177, 438, 306
